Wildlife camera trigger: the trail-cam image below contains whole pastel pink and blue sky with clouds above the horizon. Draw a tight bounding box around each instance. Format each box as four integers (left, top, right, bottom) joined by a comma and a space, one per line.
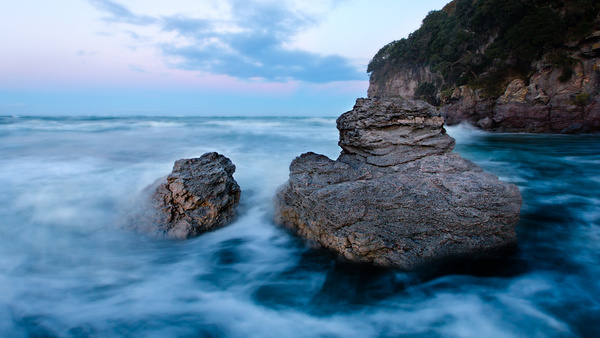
0, 0, 449, 116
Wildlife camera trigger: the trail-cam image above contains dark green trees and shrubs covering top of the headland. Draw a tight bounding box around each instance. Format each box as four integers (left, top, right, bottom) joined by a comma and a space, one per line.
367, 0, 600, 101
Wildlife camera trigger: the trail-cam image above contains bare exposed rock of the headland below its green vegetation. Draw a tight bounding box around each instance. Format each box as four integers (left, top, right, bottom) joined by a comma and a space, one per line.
368, 53, 600, 133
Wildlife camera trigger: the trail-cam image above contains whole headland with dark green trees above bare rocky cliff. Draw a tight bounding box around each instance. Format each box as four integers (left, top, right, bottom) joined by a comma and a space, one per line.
368, 0, 600, 133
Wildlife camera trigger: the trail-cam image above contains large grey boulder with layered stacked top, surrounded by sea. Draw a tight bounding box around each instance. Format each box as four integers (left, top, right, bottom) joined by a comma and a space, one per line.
275, 99, 521, 269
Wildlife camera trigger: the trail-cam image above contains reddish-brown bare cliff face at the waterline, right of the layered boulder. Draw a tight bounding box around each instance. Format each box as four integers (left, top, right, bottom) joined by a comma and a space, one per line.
440, 44, 600, 133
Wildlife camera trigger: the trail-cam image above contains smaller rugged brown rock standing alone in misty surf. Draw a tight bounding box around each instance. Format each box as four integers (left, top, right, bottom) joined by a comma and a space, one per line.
134, 152, 241, 239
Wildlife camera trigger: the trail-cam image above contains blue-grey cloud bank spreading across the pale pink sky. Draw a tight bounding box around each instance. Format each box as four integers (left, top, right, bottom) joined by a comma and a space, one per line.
89, 0, 366, 83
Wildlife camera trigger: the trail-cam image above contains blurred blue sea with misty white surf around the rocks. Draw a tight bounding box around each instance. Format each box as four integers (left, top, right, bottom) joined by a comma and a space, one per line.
0, 117, 600, 337
